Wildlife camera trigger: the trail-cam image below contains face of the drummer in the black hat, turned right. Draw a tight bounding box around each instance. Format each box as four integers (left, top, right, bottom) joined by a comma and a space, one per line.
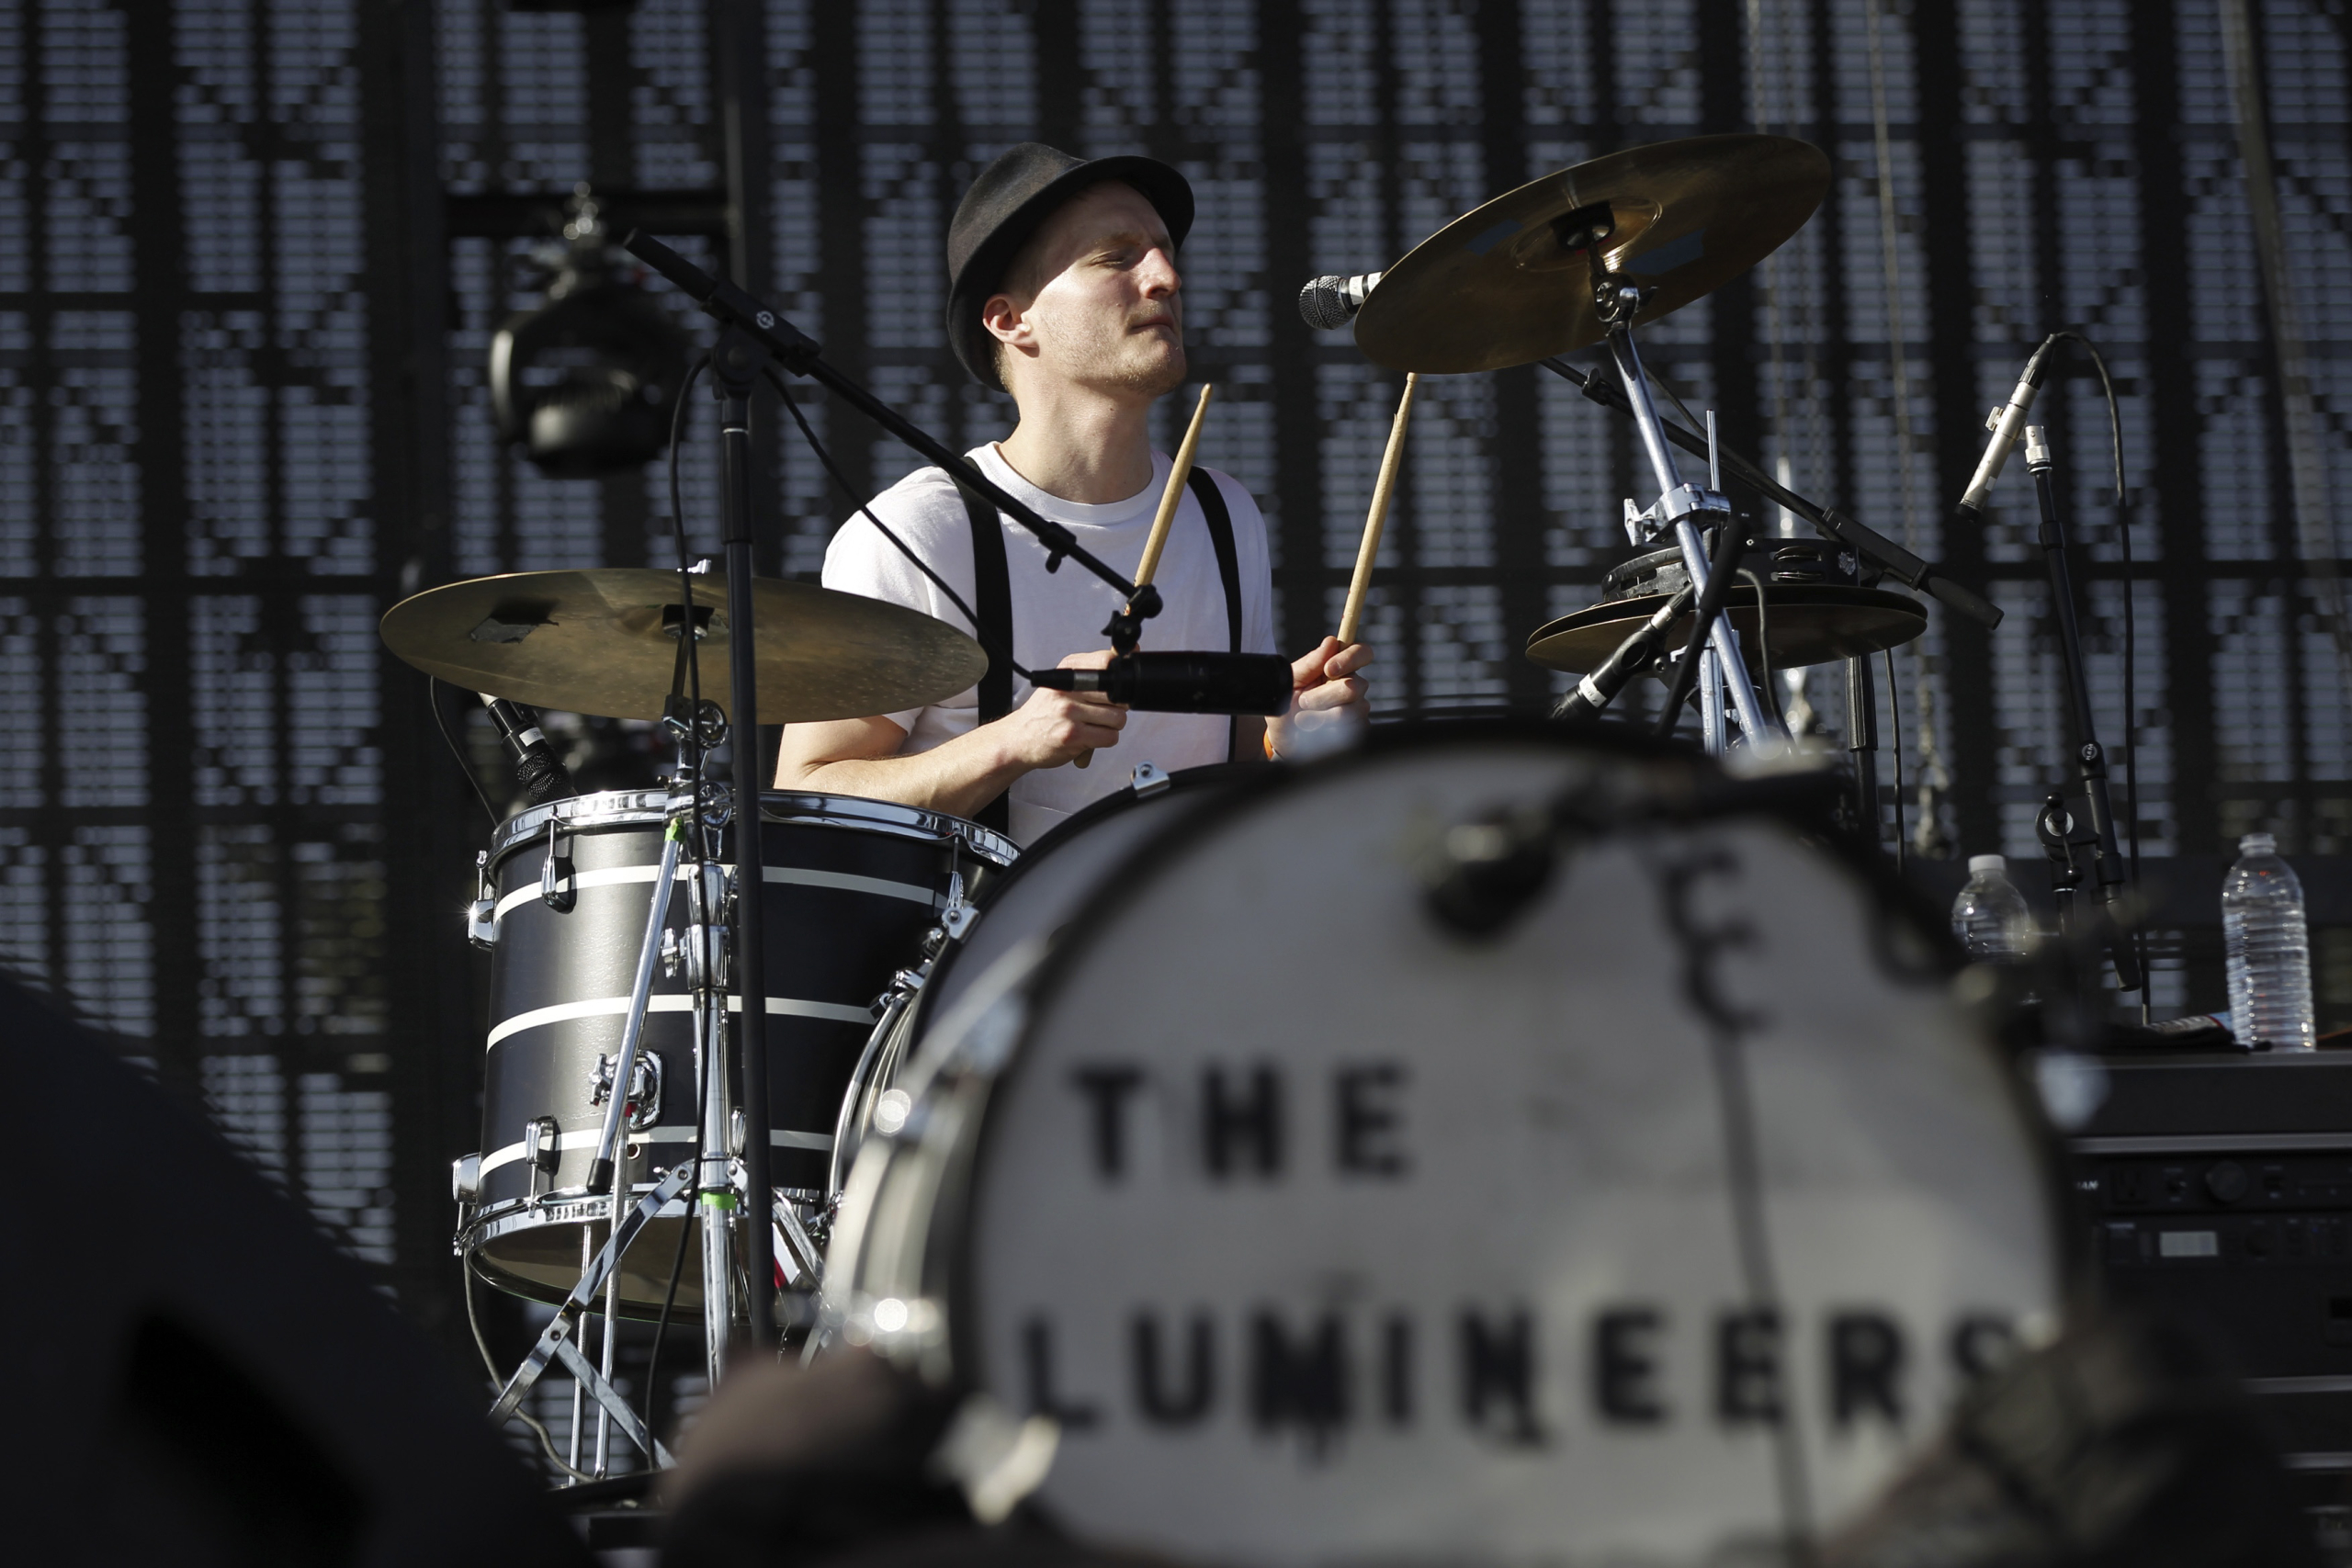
981, 181, 1185, 402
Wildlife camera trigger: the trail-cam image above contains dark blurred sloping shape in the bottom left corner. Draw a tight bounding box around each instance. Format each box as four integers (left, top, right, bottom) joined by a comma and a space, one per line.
0, 980, 588, 1568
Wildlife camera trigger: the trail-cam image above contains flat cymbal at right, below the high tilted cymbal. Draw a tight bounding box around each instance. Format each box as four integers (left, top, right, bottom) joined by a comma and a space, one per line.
1526, 583, 1927, 674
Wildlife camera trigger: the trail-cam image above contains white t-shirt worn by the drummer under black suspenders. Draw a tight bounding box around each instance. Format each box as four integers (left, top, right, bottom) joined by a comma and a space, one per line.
823, 445, 1275, 844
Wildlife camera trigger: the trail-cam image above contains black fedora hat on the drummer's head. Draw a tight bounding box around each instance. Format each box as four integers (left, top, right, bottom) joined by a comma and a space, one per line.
948, 141, 1193, 390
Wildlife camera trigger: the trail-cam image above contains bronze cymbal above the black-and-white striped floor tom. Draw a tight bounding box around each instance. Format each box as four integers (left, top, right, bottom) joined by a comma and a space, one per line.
381, 567, 988, 724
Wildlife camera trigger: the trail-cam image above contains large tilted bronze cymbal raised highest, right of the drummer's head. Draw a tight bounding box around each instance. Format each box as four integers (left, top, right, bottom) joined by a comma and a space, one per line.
1355, 136, 1830, 374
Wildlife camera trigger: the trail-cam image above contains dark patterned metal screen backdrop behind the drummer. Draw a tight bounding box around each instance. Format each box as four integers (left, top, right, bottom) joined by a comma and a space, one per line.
0, 0, 2352, 1354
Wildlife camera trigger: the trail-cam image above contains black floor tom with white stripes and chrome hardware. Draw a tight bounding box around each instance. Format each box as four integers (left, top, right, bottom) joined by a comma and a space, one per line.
457, 790, 1018, 1312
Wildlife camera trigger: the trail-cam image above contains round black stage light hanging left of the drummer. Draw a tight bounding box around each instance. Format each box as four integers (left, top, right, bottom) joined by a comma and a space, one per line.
489, 186, 689, 479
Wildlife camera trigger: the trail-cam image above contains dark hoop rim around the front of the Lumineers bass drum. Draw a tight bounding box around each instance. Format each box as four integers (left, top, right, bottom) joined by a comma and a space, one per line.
835, 717, 2093, 1392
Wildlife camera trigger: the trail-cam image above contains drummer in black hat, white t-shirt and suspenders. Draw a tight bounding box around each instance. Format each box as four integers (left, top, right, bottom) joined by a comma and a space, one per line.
776, 141, 1371, 844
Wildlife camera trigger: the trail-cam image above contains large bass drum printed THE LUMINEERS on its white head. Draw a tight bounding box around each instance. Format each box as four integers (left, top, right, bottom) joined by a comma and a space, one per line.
823, 727, 2070, 1568
